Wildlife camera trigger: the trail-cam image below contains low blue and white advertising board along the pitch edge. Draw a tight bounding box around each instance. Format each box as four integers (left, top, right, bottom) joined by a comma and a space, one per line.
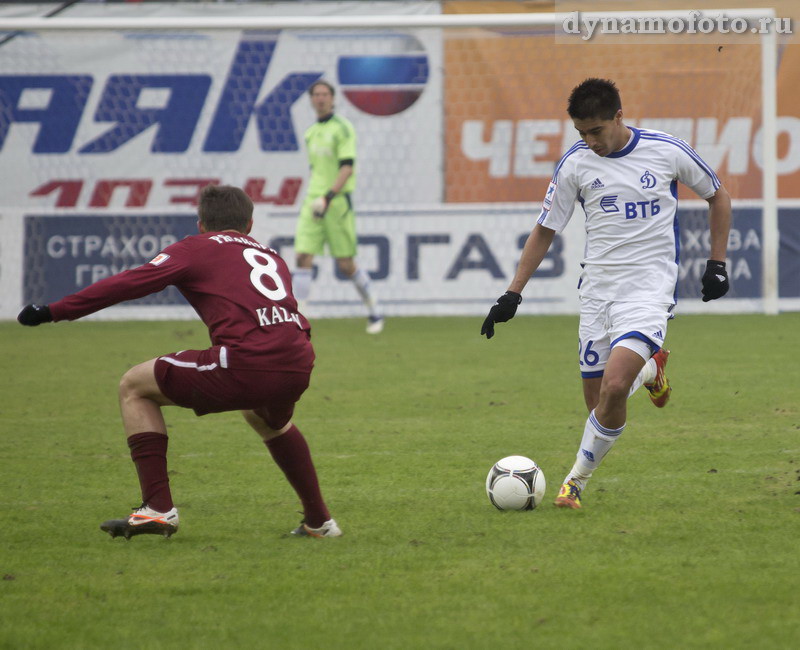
9, 202, 800, 320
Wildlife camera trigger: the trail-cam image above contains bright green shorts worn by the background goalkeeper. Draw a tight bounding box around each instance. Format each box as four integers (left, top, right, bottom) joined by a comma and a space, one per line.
294, 194, 356, 258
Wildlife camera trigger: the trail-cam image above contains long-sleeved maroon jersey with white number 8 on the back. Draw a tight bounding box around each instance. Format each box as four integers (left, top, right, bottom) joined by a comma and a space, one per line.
50, 231, 314, 372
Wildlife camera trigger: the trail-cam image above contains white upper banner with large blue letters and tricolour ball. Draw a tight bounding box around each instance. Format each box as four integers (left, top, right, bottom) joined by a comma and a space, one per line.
0, 2, 443, 211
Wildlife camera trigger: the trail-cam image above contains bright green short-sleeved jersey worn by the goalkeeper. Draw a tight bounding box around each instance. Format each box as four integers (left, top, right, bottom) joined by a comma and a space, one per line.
305, 114, 356, 198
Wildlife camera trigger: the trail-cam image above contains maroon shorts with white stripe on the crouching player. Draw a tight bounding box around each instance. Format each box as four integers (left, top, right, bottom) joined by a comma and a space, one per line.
155, 346, 311, 430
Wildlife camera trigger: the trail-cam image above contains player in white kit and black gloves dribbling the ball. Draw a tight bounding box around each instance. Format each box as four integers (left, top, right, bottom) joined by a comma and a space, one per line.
481, 79, 731, 508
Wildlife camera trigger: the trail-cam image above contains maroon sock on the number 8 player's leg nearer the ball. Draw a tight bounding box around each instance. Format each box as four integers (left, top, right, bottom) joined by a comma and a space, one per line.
264, 425, 331, 528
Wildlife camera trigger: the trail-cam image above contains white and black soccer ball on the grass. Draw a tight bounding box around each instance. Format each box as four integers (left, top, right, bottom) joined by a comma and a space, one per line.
486, 456, 547, 510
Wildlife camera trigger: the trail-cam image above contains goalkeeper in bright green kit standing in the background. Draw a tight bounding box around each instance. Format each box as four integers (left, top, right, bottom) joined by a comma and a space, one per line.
293, 80, 384, 334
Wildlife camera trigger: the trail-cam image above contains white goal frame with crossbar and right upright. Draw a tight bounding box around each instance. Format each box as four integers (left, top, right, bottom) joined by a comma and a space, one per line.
0, 9, 779, 314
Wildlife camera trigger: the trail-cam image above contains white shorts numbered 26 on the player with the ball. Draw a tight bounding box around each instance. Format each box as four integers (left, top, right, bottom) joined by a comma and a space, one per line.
578, 298, 674, 378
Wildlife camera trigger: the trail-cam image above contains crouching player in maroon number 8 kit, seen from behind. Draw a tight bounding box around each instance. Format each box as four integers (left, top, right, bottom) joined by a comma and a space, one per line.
17, 186, 342, 538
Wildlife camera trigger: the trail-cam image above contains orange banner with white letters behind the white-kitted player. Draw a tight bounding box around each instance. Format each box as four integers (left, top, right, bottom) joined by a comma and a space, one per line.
444, 3, 800, 202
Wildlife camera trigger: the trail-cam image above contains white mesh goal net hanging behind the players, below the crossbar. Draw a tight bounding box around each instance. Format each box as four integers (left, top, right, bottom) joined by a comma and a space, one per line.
0, 2, 778, 318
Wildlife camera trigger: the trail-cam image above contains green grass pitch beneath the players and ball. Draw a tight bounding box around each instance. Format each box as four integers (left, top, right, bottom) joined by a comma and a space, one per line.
0, 314, 800, 650
